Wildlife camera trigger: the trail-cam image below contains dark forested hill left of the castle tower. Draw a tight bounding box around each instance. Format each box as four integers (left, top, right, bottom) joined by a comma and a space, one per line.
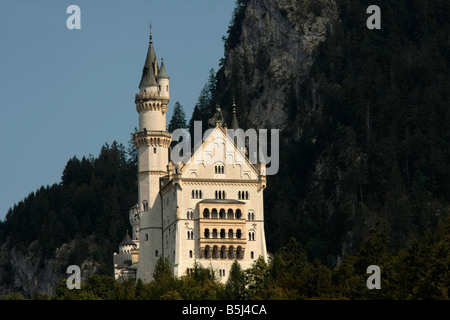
0, 142, 137, 274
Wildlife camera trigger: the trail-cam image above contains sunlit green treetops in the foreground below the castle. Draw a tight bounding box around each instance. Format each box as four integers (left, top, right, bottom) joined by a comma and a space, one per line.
19, 218, 450, 300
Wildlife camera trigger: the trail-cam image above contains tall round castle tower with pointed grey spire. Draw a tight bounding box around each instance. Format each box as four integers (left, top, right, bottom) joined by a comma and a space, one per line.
133, 31, 171, 281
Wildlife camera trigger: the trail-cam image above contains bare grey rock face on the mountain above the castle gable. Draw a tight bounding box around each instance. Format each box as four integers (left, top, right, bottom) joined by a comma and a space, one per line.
224, 0, 338, 130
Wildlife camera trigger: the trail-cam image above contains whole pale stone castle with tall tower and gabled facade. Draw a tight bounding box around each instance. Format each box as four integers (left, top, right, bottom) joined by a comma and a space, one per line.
113, 27, 268, 282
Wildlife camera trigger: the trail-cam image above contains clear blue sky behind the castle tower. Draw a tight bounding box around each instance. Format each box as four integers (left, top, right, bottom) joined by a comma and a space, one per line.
0, 0, 235, 219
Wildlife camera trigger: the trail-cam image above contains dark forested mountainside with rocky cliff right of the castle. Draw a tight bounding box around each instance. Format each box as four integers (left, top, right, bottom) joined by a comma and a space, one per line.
212, 0, 450, 265
